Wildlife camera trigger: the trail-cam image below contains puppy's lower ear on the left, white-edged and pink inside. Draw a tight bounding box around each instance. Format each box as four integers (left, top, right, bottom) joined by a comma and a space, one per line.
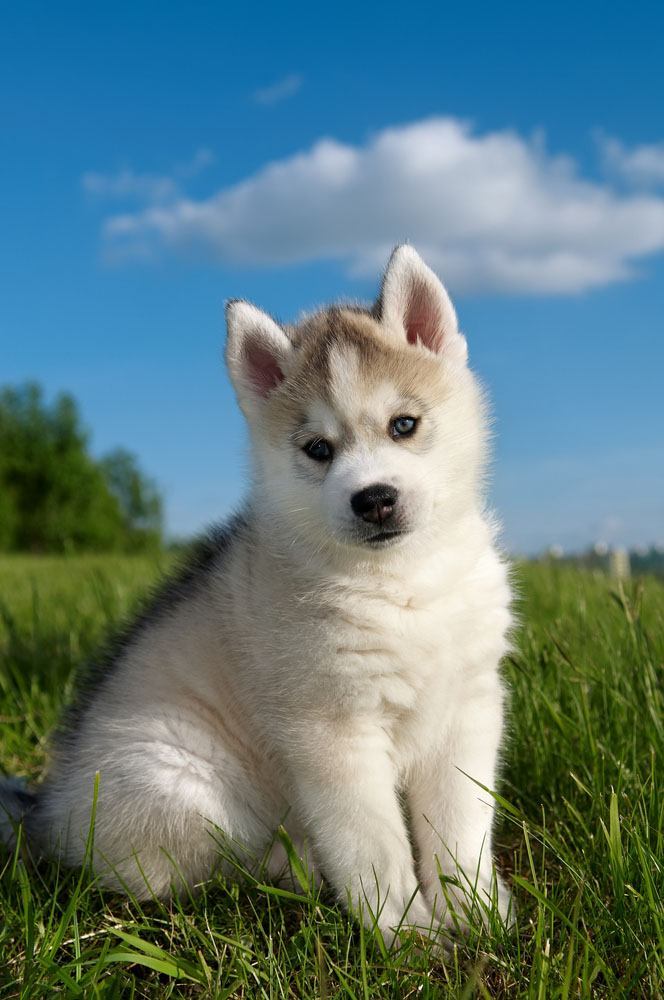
226, 299, 293, 400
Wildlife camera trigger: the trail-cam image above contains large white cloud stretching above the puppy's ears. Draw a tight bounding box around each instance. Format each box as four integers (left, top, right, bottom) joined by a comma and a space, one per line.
100, 118, 664, 294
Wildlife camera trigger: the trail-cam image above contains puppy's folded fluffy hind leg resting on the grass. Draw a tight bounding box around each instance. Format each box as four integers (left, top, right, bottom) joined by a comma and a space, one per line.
33, 733, 281, 898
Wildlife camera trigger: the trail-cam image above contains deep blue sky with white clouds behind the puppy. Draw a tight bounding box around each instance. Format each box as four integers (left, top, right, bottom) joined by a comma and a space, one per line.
0, 0, 664, 552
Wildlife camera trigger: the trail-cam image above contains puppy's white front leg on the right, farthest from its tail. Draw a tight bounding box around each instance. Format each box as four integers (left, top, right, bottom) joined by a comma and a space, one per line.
408, 679, 510, 923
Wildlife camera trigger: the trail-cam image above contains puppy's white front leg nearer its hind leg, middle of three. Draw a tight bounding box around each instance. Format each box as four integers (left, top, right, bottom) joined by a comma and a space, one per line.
293, 727, 431, 940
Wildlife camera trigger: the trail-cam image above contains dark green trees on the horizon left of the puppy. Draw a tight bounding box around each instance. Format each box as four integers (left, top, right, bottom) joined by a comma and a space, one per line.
0, 383, 163, 552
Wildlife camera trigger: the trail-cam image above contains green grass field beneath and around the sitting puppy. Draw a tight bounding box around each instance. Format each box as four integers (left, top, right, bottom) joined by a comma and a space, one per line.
0, 557, 664, 1000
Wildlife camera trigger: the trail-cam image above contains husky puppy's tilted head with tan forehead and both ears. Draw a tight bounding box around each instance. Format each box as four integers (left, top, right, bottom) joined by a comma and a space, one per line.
227, 246, 485, 554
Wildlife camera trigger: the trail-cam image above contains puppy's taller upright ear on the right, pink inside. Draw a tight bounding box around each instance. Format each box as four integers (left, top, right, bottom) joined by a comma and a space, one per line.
376, 244, 468, 362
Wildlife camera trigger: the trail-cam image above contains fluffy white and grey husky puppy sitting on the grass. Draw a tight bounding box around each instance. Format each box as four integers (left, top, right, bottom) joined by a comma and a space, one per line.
1, 246, 510, 935
